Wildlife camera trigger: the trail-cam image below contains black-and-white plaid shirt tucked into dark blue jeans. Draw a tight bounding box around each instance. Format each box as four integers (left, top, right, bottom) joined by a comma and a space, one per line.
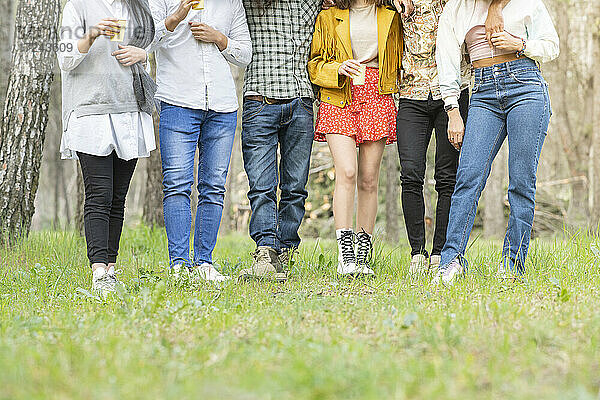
244, 0, 322, 99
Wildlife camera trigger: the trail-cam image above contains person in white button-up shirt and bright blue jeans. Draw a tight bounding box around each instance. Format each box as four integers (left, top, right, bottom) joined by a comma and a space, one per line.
150, 0, 252, 281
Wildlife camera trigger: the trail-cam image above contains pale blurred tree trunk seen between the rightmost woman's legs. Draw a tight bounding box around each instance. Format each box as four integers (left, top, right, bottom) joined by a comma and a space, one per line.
483, 143, 508, 237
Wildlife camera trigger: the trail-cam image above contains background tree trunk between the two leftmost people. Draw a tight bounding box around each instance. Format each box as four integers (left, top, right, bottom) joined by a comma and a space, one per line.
143, 57, 165, 226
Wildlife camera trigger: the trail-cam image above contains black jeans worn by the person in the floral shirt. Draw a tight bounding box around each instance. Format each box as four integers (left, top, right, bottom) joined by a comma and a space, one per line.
397, 90, 469, 256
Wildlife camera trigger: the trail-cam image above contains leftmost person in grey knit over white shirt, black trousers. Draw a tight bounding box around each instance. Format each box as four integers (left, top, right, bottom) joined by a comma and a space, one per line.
57, 0, 156, 295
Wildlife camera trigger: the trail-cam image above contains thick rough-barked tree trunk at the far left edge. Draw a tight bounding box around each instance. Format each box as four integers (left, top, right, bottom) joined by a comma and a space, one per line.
0, 0, 60, 242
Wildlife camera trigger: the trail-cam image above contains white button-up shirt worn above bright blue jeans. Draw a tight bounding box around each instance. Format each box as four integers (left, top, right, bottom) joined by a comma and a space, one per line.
150, 0, 252, 112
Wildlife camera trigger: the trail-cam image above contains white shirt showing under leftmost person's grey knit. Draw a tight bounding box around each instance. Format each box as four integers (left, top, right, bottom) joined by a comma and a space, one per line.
57, 0, 156, 160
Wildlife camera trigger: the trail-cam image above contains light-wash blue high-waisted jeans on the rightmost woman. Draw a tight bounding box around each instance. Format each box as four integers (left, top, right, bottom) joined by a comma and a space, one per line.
442, 58, 552, 274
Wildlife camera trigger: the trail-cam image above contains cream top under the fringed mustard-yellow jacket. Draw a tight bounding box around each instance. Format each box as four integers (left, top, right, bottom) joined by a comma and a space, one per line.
350, 4, 379, 68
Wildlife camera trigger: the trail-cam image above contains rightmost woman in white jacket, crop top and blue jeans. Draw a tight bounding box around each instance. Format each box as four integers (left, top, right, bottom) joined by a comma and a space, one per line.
435, 0, 559, 284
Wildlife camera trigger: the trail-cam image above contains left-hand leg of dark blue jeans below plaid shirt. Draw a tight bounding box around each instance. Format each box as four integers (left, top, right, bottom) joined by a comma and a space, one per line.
242, 100, 281, 251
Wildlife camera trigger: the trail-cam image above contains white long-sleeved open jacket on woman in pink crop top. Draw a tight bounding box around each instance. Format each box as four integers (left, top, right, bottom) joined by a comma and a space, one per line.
436, 0, 560, 106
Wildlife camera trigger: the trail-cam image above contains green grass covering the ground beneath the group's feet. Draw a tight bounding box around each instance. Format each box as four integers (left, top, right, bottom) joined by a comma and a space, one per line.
0, 228, 600, 399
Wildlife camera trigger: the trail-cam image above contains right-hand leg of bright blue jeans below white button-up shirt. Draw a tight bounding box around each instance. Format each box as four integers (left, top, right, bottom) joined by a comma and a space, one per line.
194, 111, 237, 265
